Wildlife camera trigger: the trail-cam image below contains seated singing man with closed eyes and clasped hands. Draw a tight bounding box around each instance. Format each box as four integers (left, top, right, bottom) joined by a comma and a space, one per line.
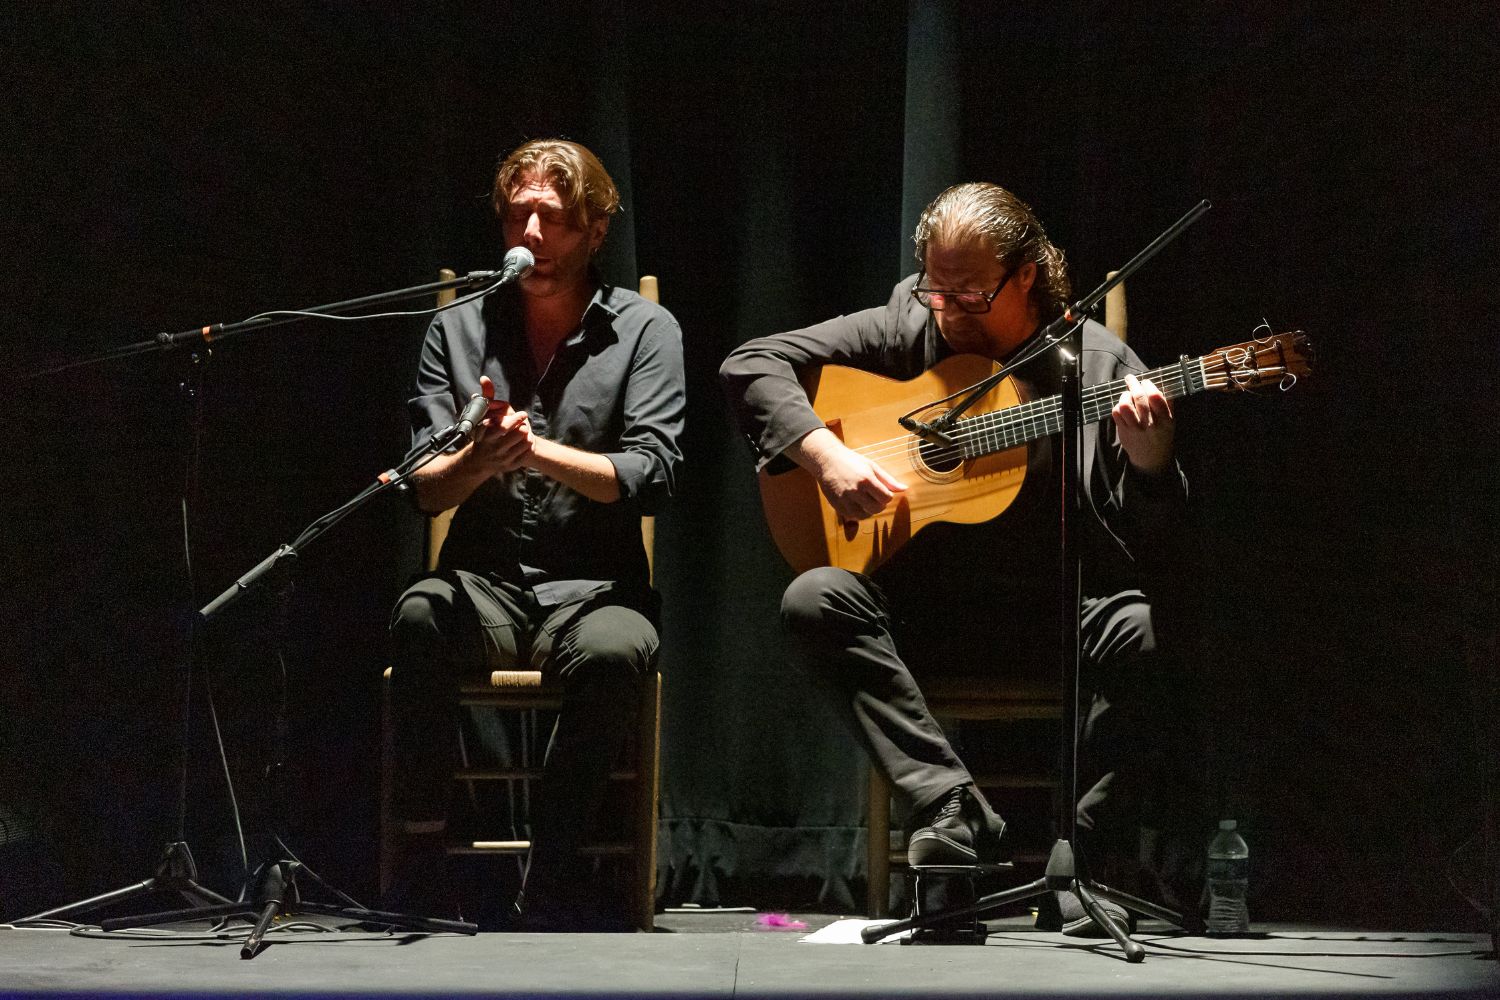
389, 139, 684, 931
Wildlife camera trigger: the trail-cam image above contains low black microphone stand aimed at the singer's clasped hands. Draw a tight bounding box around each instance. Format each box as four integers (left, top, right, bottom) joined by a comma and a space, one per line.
99, 424, 479, 958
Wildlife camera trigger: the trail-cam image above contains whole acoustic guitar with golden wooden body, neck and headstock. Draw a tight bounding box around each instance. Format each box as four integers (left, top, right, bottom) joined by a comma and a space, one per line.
761, 331, 1313, 573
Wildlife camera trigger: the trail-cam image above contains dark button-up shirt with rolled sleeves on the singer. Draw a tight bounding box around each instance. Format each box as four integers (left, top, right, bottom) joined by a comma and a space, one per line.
407, 283, 686, 604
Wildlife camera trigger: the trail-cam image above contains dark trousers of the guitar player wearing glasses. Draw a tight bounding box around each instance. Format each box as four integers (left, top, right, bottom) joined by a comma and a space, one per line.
782, 567, 1157, 863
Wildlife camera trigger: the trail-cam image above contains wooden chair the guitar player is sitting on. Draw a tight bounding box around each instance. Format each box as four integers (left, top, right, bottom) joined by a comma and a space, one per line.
866, 271, 1128, 918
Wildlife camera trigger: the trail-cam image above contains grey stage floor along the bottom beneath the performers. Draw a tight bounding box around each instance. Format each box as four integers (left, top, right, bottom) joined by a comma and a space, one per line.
0, 913, 1500, 999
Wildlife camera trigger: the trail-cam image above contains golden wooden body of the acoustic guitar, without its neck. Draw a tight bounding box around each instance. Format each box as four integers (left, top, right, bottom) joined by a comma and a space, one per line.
761, 354, 1028, 573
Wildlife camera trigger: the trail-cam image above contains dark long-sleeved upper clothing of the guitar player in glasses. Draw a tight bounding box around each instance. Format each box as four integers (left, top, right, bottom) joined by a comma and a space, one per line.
720, 274, 1187, 613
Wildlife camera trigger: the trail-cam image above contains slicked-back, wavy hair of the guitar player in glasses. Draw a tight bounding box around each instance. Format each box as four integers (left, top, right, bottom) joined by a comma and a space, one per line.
912, 181, 1073, 319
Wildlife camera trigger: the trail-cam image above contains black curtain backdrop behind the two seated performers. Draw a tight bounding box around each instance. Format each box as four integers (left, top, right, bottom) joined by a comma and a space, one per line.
0, 0, 1497, 925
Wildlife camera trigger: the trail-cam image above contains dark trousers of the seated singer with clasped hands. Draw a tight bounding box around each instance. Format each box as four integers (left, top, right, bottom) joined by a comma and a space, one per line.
390, 571, 659, 900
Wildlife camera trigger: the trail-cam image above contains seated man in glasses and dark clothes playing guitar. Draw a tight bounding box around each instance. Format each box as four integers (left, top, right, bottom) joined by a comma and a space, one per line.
720, 183, 1196, 936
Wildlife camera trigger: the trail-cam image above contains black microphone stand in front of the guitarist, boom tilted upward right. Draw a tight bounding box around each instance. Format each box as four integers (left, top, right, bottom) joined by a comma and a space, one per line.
860, 201, 1209, 964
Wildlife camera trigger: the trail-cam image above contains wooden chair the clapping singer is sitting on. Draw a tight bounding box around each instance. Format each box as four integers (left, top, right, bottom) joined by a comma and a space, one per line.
380, 270, 662, 931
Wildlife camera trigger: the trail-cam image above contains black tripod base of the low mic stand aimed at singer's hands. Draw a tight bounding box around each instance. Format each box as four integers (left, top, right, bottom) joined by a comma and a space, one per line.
99, 861, 479, 958
